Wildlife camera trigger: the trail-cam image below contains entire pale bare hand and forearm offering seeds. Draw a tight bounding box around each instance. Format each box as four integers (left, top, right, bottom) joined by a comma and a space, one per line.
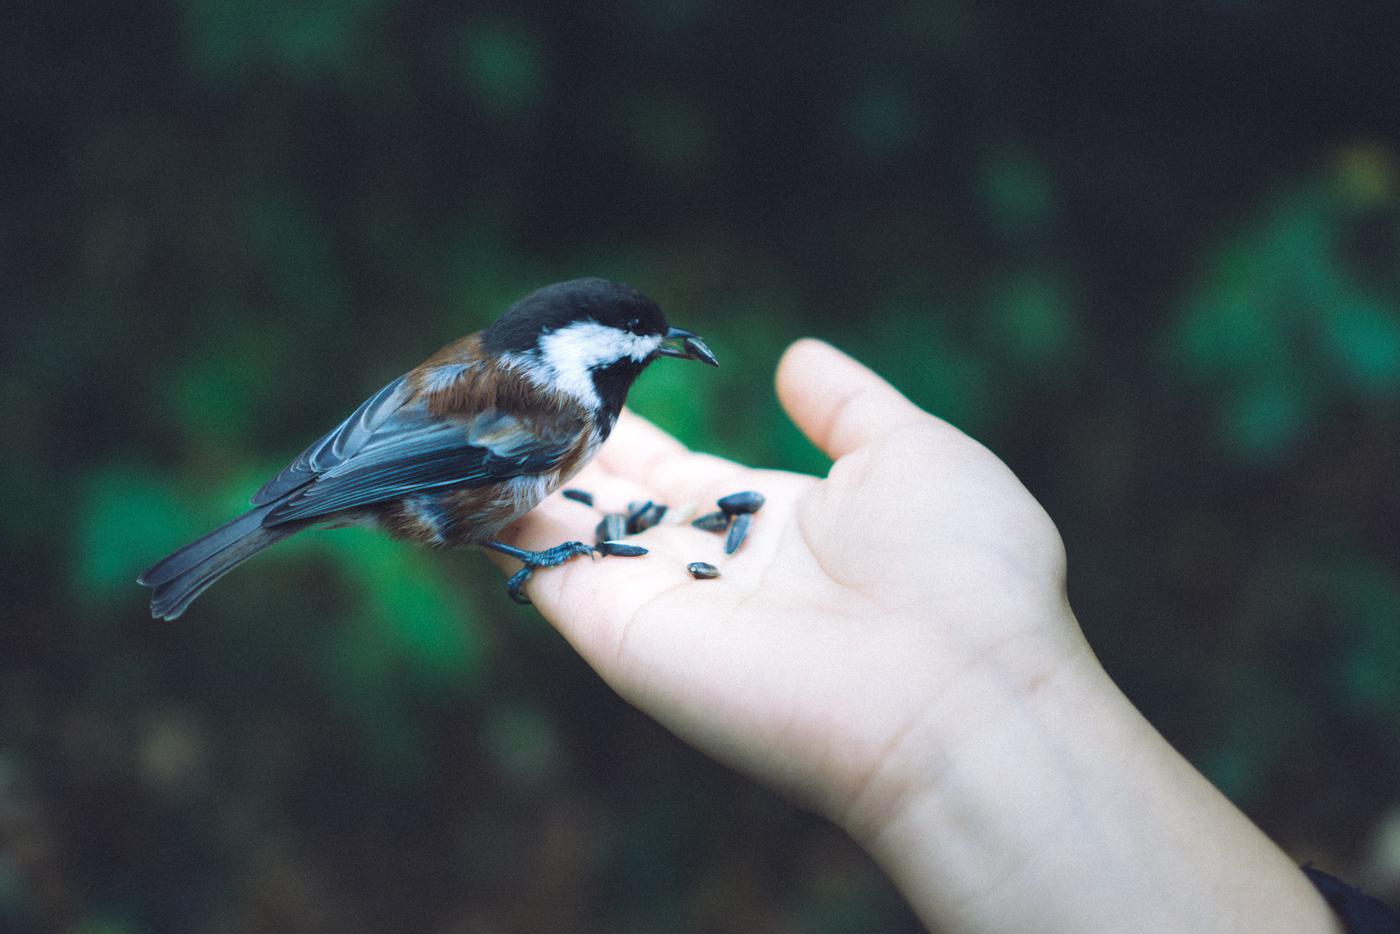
498, 340, 1343, 934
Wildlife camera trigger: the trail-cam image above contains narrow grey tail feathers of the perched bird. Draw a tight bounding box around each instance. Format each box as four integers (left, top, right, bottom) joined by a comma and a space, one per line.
136, 504, 304, 619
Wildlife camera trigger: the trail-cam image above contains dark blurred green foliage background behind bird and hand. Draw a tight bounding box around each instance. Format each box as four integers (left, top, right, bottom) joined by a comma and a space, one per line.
0, 0, 1400, 934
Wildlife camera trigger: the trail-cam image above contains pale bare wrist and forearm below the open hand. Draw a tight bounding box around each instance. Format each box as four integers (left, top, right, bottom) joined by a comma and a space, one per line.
846, 621, 1336, 934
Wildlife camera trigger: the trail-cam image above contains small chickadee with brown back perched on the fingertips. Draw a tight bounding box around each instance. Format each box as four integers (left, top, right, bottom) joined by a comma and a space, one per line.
137, 279, 720, 619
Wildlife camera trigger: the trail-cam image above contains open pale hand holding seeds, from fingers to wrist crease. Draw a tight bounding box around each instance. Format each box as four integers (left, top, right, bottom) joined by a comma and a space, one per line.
500, 340, 1085, 822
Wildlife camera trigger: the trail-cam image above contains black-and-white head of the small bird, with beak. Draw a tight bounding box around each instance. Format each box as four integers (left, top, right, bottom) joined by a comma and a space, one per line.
482, 279, 720, 421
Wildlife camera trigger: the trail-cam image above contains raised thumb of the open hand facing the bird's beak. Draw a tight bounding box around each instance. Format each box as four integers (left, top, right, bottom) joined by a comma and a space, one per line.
777, 337, 956, 459
